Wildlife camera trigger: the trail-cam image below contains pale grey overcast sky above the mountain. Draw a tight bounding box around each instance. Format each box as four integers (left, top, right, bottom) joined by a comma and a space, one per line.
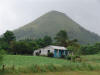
0, 0, 100, 35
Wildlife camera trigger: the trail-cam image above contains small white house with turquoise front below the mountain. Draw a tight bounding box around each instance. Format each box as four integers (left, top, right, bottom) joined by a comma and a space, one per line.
33, 45, 69, 57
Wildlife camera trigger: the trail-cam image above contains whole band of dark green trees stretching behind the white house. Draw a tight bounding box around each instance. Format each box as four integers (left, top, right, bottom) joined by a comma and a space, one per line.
0, 30, 100, 55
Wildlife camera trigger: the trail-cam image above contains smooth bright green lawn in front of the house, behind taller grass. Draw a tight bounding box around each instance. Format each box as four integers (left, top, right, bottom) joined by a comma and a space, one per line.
3, 55, 70, 67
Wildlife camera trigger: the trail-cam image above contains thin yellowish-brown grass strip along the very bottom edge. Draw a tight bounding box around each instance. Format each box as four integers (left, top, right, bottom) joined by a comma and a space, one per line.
4, 71, 100, 75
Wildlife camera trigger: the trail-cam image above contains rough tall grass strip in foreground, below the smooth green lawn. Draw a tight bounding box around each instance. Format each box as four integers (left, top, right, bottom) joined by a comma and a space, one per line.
1, 63, 100, 73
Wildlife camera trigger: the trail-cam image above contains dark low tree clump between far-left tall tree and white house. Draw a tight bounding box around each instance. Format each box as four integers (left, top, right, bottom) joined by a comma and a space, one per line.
11, 41, 34, 55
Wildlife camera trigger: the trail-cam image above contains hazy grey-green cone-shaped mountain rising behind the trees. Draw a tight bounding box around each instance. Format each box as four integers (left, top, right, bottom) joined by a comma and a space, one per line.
14, 11, 100, 44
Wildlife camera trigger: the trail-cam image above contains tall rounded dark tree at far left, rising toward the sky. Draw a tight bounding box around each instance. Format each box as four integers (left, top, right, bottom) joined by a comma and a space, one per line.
3, 31, 16, 44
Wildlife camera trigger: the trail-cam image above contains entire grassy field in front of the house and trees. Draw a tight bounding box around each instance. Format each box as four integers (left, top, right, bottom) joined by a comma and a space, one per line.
0, 54, 100, 75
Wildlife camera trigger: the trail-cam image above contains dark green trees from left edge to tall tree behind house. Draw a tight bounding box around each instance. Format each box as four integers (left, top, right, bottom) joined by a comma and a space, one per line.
0, 31, 52, 55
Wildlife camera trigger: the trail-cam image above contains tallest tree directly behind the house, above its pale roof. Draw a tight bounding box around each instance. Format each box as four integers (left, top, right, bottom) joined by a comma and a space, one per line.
55, 30, 68, 47
